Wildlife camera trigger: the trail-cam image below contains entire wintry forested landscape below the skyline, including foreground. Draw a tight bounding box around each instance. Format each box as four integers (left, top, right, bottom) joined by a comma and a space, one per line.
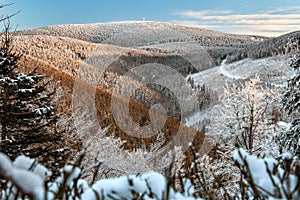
0, 16, 300, 199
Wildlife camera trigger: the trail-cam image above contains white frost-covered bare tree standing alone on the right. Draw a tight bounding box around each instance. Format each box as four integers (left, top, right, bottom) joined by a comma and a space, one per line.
210, 76, 276, 154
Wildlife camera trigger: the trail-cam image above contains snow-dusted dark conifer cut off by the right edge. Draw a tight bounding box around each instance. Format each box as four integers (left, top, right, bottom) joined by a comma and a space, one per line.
279, 54, 300, 156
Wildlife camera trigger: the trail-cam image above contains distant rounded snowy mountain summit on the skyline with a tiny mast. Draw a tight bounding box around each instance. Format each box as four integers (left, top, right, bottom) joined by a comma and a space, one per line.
15, 21, 265, 47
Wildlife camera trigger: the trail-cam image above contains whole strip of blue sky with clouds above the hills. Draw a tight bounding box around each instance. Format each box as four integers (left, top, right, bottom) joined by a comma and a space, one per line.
0, 0, 300, 36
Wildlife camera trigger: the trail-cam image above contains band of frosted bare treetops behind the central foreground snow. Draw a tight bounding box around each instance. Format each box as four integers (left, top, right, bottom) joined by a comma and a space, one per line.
69, 111, 185, 182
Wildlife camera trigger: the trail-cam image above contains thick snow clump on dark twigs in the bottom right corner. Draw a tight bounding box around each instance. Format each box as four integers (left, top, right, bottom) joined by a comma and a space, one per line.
233, 149, 299, 199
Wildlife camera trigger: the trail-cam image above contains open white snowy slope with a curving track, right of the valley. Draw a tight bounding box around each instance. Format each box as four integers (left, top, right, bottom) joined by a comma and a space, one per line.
185, 56, 294, 130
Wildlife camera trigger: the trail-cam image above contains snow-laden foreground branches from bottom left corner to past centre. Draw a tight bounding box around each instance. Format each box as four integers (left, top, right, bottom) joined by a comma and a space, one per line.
0, 153, 194, 200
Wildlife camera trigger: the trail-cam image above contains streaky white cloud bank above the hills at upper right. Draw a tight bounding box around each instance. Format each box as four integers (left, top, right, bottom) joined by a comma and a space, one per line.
172, 6, 300, 36
